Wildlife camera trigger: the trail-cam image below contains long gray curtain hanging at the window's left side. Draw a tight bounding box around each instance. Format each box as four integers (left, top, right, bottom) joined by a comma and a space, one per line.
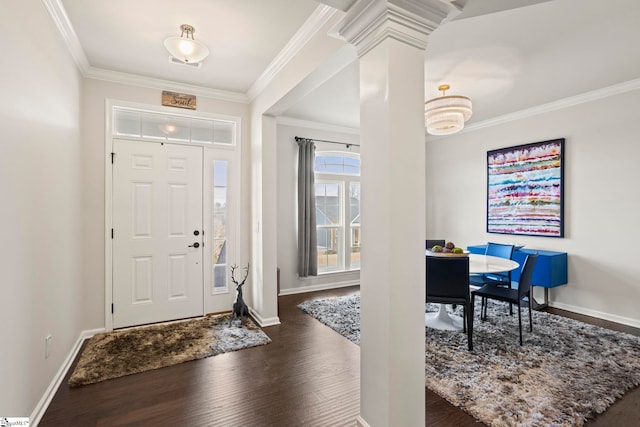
297, 138, 318, 277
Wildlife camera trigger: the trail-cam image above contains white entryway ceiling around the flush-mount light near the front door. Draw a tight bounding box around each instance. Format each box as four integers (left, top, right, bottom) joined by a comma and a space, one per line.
58, 0, 318, 94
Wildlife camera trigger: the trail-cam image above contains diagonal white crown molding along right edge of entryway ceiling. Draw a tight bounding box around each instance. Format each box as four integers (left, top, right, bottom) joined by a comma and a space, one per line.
247, 5, 337, 101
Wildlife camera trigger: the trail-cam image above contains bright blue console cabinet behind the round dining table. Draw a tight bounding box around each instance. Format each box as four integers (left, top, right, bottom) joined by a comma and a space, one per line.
467, 245, 568, 290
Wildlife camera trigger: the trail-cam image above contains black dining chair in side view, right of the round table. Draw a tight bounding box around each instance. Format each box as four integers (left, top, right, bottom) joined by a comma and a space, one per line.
471, 254, 538, 345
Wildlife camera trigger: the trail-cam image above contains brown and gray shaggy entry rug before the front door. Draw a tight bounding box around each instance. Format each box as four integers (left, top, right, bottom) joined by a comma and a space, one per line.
69, 314, 271, 387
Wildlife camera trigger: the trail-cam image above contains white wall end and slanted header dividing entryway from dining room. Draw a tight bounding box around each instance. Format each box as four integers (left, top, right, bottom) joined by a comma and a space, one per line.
247, 5, 345, 320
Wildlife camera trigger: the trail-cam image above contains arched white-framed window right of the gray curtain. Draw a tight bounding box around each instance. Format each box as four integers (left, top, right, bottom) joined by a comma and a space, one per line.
314, 152, 360, 274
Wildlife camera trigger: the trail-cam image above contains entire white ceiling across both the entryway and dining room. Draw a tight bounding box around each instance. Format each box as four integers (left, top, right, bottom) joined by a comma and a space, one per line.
57, 0, 640, 128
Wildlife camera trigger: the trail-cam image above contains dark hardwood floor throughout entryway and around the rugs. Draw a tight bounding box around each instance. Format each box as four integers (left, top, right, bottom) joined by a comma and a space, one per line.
39, 287, 640, 427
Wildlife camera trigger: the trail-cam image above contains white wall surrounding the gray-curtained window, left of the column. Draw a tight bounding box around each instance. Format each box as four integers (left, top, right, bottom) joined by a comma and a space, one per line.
277, 124, 360, 294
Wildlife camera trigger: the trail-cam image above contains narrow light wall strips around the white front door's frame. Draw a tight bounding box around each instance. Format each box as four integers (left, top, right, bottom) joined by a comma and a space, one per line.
83, 79, 252, 329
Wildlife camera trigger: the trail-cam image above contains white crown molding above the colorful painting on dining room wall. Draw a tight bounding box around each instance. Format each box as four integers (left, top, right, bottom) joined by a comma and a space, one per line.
461, 78, 640, 133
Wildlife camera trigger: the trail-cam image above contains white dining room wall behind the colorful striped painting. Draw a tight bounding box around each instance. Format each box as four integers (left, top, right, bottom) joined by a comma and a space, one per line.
426, 85, 640, 327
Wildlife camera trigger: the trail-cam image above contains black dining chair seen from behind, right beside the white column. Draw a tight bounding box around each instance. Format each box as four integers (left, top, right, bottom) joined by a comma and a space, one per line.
426, 256, 473, 351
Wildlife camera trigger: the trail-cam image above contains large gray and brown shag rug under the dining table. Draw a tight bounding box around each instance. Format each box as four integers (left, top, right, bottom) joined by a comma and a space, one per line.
298, 295, 640, 426
